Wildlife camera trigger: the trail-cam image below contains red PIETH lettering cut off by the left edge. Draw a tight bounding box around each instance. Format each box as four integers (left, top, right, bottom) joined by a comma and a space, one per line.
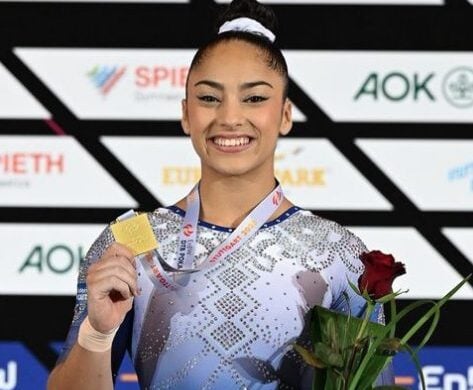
0, 152, 64, 175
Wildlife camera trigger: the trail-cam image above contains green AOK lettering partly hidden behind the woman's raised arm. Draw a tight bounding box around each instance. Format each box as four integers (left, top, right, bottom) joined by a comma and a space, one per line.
18, 244, 84, 274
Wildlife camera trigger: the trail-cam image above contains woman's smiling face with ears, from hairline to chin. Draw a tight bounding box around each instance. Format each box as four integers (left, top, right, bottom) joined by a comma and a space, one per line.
182, 40, 292, 178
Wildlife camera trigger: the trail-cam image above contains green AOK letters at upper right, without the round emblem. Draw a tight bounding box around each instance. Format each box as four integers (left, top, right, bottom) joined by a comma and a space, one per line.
354, 71, 436, 102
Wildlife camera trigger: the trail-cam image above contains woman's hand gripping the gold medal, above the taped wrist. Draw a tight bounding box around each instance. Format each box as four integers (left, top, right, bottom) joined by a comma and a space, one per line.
87, 243, 138, 333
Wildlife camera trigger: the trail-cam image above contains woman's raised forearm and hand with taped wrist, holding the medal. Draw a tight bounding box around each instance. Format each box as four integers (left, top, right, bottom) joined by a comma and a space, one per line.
48, 243, 137, 390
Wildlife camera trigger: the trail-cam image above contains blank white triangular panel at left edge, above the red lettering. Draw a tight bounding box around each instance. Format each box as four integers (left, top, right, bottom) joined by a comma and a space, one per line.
0, 63, 51, 119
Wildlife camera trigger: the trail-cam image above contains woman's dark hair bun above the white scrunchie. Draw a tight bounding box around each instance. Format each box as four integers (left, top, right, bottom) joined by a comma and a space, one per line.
217, 0, 277, 33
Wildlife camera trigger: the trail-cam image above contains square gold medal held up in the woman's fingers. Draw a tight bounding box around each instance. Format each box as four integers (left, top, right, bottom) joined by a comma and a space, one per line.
110, 213, 158, 256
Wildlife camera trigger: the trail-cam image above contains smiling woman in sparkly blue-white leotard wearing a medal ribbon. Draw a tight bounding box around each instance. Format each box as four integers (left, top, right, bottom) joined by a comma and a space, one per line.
49, 0, 390, 390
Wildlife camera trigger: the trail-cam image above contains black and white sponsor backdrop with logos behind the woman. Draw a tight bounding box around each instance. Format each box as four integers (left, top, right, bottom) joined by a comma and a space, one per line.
0, 0, 473, 390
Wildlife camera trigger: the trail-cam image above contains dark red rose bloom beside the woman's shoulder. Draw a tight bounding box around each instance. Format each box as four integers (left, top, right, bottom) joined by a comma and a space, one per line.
358, 251, 406, 299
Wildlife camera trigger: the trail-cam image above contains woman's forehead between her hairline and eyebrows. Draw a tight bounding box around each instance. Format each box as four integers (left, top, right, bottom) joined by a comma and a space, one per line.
189, 40, 282, 85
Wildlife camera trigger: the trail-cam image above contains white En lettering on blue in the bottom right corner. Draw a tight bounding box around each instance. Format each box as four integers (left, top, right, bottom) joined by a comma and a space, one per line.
419, 365, 473, 390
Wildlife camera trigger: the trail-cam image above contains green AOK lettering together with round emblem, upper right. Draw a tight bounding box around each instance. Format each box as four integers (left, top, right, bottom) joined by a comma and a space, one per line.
353, 66, 473, 108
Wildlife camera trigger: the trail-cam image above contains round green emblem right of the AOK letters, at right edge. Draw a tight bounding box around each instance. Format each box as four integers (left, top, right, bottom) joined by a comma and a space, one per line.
442, 67, 473, 108
